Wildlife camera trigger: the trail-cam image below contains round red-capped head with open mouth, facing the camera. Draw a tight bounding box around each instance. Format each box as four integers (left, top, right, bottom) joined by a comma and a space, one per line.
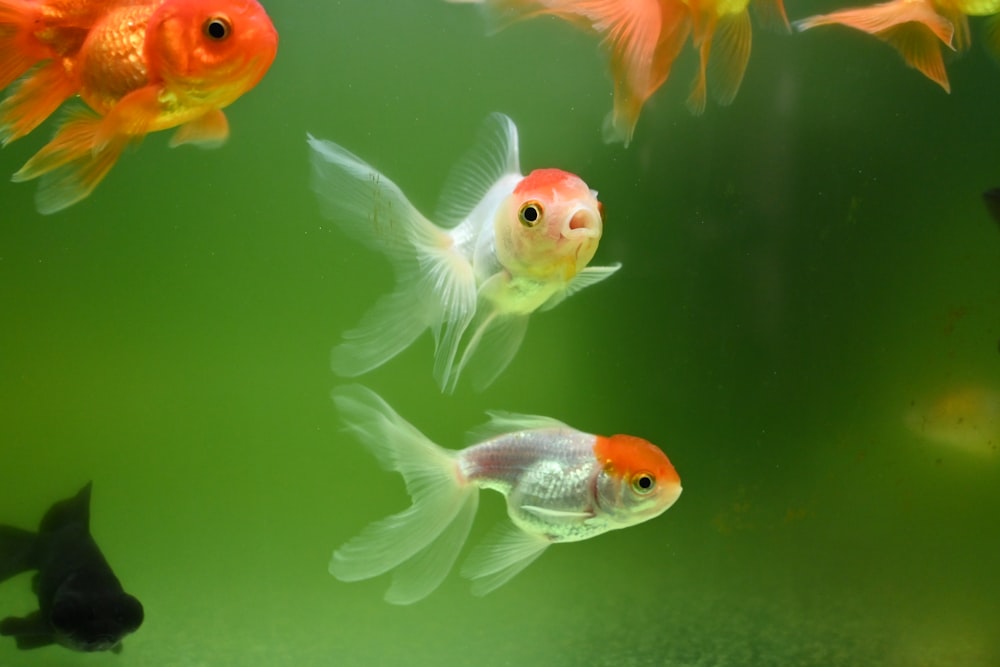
494, 169, 604, 281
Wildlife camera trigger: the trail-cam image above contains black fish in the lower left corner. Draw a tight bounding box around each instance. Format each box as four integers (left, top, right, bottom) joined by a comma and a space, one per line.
0, 482, 143, 653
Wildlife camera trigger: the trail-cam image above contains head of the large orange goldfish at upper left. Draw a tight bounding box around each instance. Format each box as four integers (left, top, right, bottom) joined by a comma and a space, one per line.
145, 0, 278, 109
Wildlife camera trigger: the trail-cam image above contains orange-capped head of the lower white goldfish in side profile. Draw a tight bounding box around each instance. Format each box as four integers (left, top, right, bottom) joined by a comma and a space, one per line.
594, 435, 681, 527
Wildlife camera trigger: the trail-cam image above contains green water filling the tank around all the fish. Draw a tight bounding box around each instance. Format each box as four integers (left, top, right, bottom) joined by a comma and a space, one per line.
0, 0, 1000, 667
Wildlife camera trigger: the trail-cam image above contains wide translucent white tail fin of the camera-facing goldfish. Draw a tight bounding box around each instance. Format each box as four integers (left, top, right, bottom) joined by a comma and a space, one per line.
309, 136, 476, 377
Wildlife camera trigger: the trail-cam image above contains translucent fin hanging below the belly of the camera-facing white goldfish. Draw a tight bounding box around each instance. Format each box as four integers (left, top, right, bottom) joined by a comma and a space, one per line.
445, 310, 528, 392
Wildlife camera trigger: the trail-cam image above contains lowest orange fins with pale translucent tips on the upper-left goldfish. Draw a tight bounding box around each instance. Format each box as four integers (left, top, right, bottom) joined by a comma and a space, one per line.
11, 108, 129, 214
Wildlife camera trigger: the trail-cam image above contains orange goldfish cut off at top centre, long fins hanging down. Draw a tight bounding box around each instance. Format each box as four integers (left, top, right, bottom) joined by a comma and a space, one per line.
447, 0, 788, 146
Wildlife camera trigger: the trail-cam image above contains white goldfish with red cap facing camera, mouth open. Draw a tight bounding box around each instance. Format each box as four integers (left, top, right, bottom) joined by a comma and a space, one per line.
308, 113, 620, 392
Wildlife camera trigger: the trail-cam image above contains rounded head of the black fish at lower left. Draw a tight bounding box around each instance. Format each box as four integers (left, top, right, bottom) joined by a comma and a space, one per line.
49, 587, 144, 652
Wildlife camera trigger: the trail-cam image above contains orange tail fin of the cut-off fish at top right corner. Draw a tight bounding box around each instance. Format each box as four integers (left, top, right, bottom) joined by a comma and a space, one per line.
795, 0, 955, 92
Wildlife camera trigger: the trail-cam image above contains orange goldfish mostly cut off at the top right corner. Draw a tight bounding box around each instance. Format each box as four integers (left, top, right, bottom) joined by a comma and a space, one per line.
795, 0, 1000, 93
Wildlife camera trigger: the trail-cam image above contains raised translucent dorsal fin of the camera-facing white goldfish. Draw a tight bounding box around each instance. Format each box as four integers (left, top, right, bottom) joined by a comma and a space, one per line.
434, 113, 521, 227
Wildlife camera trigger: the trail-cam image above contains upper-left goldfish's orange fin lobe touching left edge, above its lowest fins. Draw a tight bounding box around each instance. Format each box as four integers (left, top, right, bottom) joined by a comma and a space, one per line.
0, 62, 77, 145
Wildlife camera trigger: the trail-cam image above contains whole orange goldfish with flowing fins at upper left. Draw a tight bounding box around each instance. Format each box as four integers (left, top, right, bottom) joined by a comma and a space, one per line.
0, 0, 278, 214
